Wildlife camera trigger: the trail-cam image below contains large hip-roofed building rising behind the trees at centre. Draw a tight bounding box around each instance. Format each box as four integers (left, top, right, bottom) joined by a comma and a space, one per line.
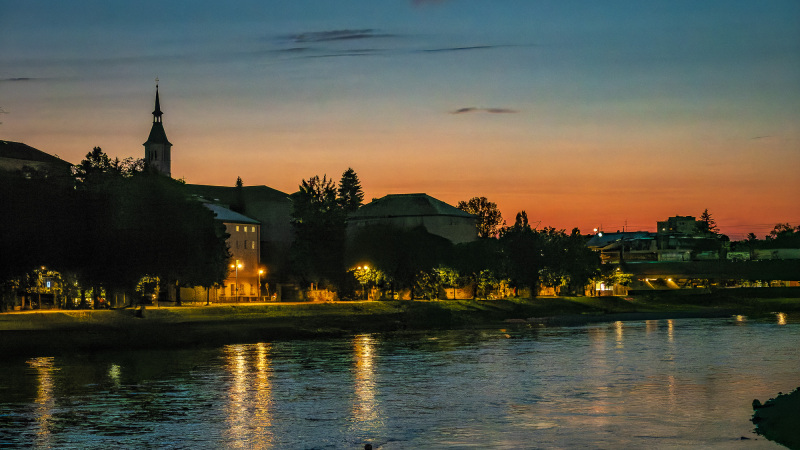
347, 194, 478, 244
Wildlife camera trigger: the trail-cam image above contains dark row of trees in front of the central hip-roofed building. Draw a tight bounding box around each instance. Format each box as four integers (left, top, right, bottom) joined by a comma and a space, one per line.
291, 169, 601, 298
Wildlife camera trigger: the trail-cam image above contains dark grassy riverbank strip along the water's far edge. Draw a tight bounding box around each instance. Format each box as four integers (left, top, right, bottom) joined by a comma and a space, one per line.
0, 292, 800, 355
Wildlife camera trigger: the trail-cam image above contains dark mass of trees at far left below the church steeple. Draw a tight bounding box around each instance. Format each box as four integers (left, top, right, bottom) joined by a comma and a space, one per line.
0, 147, 228, 308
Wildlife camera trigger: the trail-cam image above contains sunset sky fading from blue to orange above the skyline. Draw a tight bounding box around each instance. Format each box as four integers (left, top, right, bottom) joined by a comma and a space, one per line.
0, 0, 800, 239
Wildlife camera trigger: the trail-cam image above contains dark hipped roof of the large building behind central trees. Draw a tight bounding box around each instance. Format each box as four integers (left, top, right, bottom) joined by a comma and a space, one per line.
350, 194, 475, 219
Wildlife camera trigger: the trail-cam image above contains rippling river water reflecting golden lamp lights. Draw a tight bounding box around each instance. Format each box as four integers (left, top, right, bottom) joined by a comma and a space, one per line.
0, 315, 800, 449
